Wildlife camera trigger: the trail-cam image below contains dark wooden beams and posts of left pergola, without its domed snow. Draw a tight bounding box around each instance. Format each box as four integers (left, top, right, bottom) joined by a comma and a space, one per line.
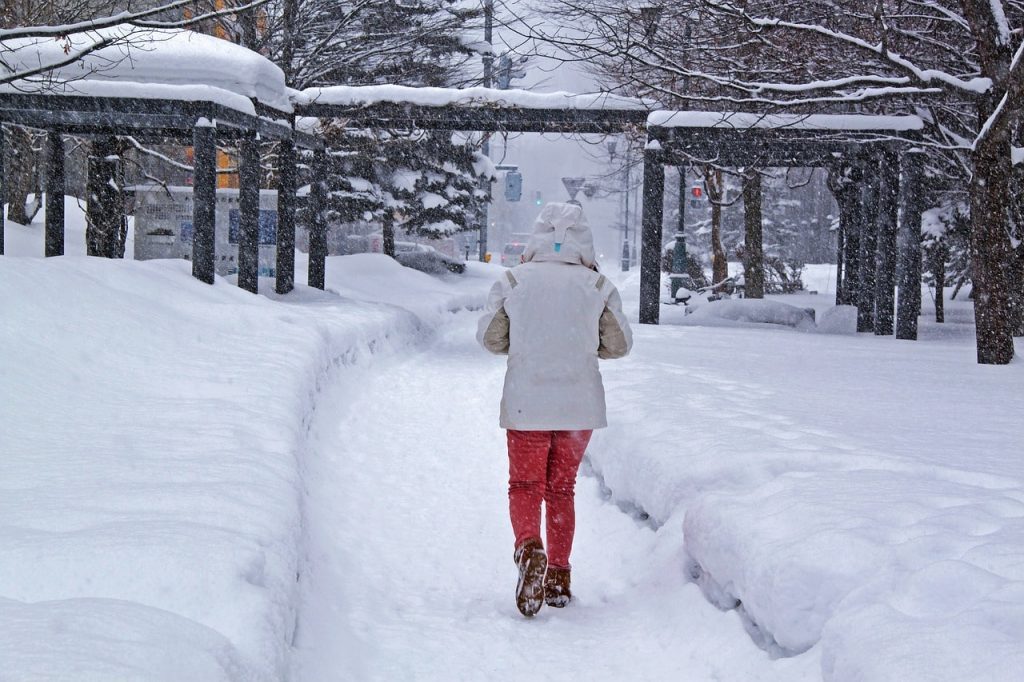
0, 91, 324, 293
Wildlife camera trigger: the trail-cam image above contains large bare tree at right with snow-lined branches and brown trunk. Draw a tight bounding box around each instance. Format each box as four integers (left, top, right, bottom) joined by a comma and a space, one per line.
520, 0, 1024, 364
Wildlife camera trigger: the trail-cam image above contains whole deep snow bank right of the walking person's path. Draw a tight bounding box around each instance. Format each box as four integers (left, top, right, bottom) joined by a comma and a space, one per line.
588, 274, 1024, 682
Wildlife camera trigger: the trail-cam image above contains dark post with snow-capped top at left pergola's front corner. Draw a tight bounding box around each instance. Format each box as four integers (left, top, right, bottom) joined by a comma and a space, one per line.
193, 118, 217, 284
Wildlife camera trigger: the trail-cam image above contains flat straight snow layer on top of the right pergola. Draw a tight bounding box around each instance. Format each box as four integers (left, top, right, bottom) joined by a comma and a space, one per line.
647, 111, 925, 132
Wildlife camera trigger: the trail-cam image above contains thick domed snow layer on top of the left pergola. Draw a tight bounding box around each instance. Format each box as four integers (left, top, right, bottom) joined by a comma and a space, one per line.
0, 27, 292, 114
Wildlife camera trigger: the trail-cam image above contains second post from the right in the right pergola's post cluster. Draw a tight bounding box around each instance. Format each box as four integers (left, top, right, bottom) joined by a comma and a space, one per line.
874, 146, 899, 336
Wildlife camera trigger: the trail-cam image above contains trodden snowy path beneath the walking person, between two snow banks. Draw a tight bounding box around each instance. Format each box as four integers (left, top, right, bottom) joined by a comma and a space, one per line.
293, 313, 820, 682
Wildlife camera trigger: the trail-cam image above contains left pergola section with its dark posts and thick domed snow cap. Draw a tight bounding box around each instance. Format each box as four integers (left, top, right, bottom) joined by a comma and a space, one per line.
0, 26, 324, 293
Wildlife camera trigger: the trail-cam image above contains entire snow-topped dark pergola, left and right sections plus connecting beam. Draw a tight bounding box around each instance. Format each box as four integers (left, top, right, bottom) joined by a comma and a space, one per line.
0, 32, 922, 338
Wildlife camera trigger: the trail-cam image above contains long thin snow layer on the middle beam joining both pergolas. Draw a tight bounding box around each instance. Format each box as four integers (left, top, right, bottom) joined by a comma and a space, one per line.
294, 85, 653, 111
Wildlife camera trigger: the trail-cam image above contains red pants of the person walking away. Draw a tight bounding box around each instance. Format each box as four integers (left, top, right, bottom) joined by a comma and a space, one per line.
508, 429, 593, 568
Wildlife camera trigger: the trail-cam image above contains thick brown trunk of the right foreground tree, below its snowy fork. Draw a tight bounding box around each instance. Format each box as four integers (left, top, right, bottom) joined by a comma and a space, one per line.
971, 133, 1014, 365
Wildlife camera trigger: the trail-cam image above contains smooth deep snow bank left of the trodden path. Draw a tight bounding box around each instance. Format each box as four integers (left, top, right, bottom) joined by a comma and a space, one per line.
0, 251, 483, 680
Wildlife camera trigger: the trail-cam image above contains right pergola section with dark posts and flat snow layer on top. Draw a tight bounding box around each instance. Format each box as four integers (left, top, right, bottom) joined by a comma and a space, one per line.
640, 112, 924, 339
